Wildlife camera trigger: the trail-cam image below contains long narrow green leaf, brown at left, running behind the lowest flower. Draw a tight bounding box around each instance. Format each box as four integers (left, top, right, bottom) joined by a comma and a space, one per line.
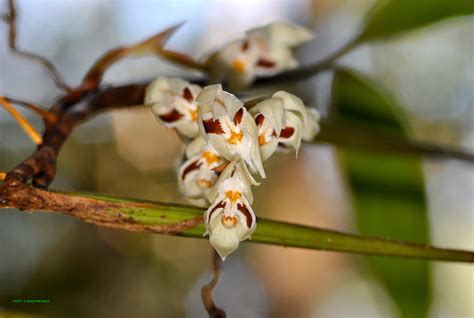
4, 189, 462, 263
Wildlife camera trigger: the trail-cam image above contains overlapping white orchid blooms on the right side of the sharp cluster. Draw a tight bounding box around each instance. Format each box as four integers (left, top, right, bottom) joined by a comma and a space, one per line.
250, 91, 319, 160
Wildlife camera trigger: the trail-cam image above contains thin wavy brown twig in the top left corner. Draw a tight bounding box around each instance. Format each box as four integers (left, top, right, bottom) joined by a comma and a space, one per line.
4, 0, 72, 92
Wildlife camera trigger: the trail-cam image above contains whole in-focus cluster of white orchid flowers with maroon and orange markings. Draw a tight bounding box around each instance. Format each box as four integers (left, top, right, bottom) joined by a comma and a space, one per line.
145, 21, 319, 259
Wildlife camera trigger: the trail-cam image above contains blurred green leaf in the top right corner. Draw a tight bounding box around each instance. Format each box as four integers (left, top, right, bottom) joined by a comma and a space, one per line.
355, 0, 474, 44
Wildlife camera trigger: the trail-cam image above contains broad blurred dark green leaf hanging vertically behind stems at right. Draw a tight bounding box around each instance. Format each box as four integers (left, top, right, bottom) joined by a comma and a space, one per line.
331, 69, 431, 318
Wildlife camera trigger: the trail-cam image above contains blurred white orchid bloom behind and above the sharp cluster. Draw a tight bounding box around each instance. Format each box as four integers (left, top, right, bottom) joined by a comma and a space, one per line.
208, 22, 312, 89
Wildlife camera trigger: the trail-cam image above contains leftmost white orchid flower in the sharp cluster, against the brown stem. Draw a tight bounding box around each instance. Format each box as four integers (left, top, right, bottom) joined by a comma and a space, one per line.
145, 77, 201, 138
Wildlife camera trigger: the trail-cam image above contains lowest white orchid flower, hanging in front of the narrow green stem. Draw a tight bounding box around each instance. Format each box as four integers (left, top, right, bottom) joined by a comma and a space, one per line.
204, 162, 257, 260
